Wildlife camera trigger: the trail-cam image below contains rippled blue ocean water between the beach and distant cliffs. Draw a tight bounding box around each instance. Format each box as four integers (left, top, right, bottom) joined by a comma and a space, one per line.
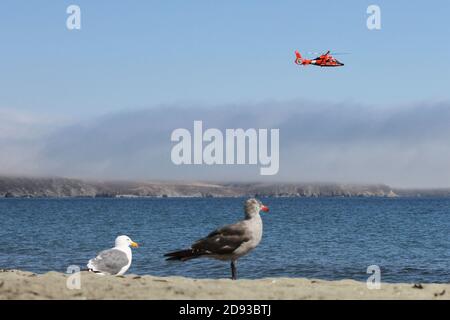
0, 198, 450, 283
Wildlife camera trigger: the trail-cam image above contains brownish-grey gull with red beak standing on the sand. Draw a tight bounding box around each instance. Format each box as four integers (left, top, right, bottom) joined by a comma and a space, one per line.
164, 198, 269, 280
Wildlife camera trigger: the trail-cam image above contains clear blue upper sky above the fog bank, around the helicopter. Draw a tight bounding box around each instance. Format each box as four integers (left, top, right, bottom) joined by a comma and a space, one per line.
0, 0, 450, 116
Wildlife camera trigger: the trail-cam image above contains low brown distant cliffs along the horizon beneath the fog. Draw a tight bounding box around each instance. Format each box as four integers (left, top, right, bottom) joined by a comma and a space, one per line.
0, 176, 414, 197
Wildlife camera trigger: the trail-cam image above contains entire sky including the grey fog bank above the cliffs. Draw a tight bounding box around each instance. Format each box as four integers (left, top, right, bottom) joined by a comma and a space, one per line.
0, 0, 450, 187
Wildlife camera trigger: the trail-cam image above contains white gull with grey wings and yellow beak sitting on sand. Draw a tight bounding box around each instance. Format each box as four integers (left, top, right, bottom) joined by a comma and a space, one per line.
87, 236, 138, 276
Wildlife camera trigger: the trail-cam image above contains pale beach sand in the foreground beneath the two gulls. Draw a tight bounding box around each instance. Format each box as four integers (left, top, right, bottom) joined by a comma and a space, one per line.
0, 270, 450, 300
